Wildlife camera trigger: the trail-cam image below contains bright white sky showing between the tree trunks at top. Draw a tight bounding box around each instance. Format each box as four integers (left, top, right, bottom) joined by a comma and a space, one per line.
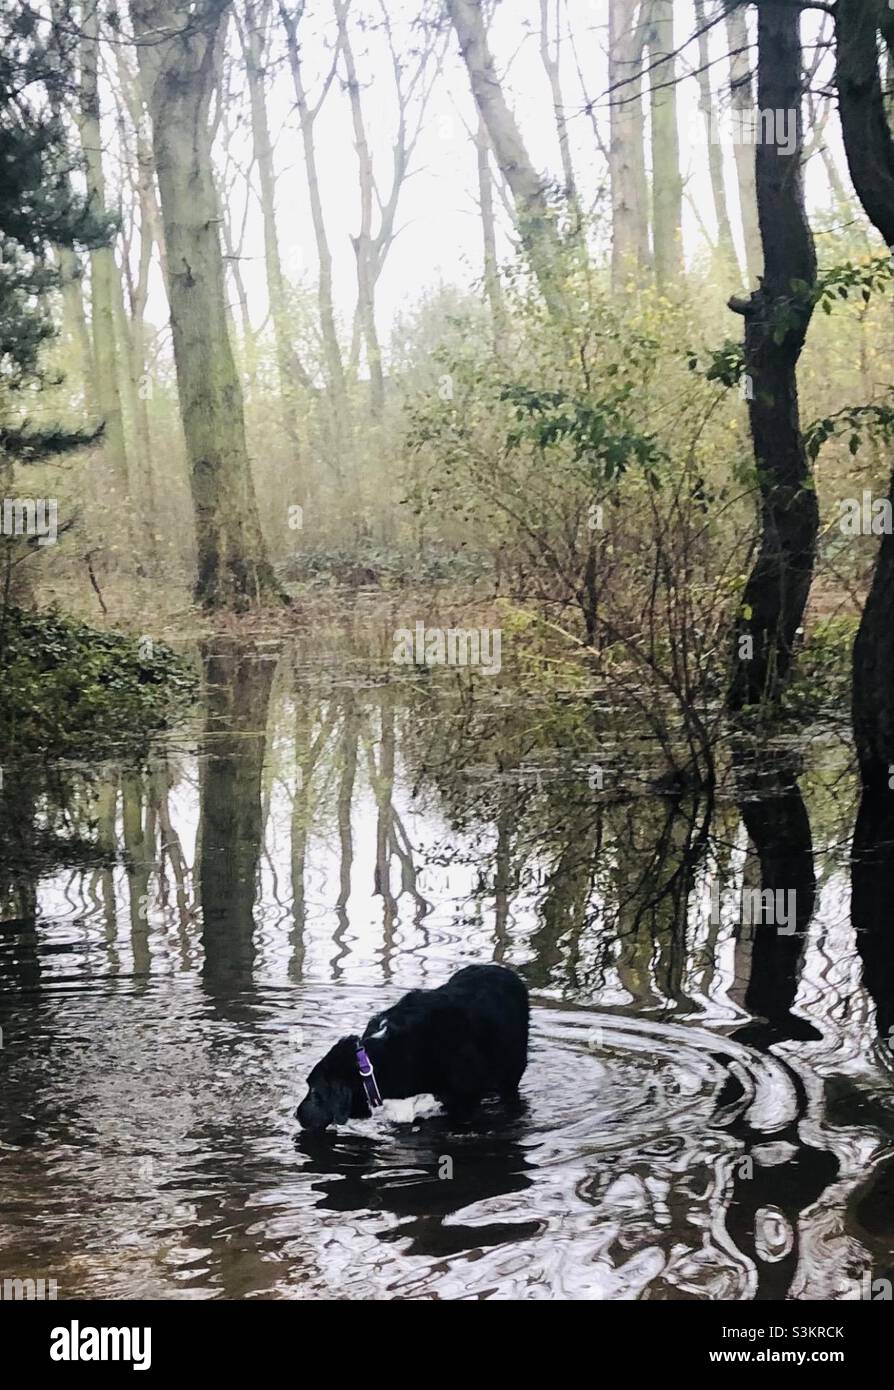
117, 0, 847, 341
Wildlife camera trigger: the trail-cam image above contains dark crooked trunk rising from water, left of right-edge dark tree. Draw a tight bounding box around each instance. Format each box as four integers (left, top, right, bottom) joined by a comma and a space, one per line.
729, 4, 819, 710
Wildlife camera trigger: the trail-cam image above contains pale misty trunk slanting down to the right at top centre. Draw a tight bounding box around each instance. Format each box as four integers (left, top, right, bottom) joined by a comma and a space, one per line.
448, 0, 566, 316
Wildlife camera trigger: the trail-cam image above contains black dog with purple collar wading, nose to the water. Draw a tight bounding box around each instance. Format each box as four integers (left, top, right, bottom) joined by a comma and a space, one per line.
296, 965, 528, 1130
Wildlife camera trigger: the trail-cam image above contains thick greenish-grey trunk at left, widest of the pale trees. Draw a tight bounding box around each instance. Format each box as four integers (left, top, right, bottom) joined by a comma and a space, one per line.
131, 0, 281, 607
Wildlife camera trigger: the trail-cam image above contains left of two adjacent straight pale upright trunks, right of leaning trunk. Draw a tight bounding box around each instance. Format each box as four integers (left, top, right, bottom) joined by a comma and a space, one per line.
609, 0, 652, 289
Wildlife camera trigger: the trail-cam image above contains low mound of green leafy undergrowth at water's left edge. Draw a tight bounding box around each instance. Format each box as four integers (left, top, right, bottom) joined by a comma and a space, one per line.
0, 609, 196, 756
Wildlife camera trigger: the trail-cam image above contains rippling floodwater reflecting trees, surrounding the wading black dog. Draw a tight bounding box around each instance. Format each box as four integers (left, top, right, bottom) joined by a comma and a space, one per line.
0, 641, 894, 1300
